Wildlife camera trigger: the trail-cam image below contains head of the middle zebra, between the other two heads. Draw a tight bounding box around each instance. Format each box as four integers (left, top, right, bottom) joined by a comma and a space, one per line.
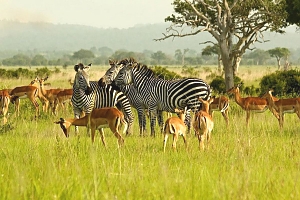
98, 59, 124, 87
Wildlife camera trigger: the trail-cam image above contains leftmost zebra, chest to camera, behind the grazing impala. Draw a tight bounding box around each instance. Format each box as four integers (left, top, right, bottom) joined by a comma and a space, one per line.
71, 63, 133, 135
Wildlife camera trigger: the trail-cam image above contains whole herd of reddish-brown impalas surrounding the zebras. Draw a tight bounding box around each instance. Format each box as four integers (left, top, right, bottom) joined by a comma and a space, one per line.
0, 66, 300, 152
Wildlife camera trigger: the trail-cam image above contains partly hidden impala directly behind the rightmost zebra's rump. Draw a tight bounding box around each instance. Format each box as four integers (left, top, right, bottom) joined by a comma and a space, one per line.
209, 96, 229, 126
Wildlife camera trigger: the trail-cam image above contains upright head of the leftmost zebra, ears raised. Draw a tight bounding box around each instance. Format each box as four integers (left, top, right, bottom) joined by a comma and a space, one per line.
73, 63, 92, 95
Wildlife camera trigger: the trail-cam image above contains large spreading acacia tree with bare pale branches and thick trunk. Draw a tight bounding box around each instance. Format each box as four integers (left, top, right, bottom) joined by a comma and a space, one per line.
156, 0, 287, 89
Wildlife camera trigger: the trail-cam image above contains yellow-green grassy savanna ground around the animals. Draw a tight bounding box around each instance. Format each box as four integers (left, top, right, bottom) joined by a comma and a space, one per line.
0, 66, 300, 199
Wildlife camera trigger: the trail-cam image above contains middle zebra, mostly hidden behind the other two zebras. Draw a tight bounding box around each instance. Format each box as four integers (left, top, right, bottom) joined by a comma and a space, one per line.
98, 60, 163, 136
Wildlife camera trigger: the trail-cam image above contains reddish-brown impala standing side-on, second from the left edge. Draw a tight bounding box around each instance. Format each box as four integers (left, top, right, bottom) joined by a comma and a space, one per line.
10, 85, 39, 118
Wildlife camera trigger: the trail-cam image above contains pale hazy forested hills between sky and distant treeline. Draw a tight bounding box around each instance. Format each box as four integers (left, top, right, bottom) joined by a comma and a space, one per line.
0, 21, 300, 54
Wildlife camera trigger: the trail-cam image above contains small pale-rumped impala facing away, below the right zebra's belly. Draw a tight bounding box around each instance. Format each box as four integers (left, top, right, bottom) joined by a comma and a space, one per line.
164, 109, 187, 152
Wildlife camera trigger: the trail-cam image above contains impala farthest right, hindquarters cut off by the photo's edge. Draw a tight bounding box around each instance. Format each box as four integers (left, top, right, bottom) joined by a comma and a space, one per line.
263, 90, 300, 128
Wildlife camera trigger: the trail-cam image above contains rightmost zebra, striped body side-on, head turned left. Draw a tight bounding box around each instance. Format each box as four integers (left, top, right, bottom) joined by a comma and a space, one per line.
102, 59, 211, 136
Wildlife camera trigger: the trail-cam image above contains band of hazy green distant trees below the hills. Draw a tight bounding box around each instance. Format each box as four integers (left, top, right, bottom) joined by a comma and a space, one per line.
0, 47, 300, 67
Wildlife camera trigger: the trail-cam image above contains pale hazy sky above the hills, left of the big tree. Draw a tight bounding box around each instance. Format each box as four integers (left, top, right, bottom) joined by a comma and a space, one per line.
0, 0, 173, 28
